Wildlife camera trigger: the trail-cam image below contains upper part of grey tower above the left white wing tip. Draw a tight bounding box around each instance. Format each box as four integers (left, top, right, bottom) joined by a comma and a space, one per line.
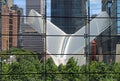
26, 0, 41, 15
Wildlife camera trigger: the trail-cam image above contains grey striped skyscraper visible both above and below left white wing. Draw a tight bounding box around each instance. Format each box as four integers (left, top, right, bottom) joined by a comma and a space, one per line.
24, 0, 44, 53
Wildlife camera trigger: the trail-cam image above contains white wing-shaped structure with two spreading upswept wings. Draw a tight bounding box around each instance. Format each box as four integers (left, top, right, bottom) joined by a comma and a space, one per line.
27, 10, 111, 66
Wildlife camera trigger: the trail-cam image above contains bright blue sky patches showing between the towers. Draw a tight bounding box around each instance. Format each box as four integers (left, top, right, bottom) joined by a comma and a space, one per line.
14, 0, 101, 16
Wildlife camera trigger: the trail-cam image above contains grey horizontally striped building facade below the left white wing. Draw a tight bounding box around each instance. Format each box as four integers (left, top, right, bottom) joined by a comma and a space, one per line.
19, 24, 44, 53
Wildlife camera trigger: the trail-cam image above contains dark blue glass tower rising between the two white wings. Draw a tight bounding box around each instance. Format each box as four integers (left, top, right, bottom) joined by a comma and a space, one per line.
51, 0, 86, 34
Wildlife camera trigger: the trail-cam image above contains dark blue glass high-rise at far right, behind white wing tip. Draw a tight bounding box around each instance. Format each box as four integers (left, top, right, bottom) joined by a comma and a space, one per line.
97, 0, 120, 63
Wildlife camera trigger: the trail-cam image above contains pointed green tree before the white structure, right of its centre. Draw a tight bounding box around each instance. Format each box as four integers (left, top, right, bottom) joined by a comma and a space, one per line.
66, 57, 85, 81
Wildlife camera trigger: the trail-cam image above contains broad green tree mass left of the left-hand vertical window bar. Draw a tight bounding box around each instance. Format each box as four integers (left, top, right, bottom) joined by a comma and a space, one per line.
1, 48, 42, 81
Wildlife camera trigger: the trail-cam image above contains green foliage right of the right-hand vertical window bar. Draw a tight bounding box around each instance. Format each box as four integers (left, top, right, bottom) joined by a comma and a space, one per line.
90, 61, 120, 81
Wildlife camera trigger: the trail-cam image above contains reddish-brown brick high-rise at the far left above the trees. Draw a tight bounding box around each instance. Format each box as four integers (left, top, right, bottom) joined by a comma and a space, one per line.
1, 5, 22, 50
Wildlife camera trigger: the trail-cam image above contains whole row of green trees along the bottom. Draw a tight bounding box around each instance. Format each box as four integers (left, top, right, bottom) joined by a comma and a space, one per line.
0, 48, 120, 81
